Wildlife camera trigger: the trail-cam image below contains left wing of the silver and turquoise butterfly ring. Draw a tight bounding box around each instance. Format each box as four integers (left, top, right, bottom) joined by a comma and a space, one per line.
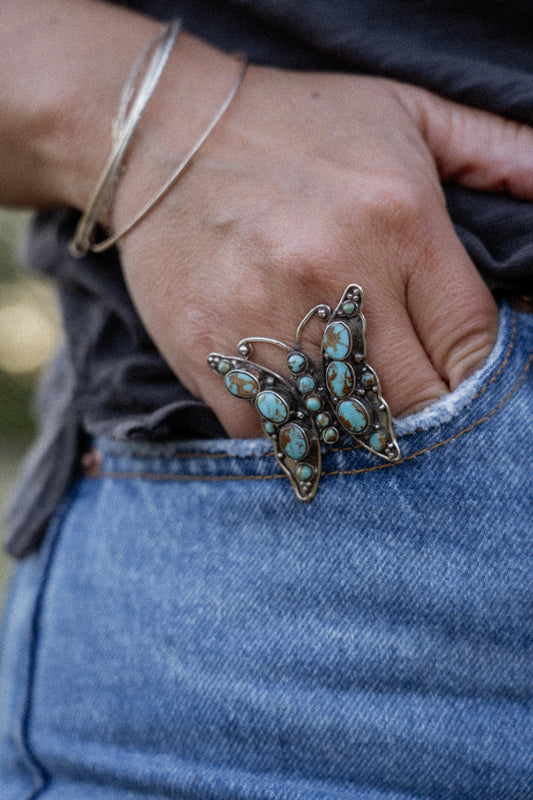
207, 353, 321, 501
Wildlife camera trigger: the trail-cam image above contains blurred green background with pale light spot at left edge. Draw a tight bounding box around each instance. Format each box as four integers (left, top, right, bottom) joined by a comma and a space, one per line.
0, 209, 60, 602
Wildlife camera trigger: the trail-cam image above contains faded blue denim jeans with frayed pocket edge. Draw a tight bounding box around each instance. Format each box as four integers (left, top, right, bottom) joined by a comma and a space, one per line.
0, 307, 533, 800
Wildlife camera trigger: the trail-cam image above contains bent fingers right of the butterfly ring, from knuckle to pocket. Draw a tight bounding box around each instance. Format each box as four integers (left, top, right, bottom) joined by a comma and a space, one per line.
363, 187, 498, 416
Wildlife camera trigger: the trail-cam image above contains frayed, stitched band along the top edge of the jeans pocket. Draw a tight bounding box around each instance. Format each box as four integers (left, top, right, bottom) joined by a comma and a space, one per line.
88, 304, 533, 481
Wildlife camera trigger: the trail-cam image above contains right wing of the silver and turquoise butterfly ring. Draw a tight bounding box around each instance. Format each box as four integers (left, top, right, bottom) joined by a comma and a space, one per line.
322, 284, 401, 461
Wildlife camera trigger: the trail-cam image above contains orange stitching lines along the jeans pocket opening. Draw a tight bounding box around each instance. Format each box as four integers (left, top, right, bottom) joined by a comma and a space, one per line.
91, 315, 533, 482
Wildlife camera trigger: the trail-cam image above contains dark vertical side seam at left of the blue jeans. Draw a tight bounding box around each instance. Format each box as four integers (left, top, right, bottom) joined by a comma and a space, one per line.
14, 490, 75, 800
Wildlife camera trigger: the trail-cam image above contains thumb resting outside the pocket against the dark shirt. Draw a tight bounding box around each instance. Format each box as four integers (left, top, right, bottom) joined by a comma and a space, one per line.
397, 86, 533, 200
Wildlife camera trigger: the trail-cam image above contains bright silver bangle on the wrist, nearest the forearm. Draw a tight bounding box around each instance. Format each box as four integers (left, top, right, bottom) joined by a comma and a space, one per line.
68, 19, 181, 258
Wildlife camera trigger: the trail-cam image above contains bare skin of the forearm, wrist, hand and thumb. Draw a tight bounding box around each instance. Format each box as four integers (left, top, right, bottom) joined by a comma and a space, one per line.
0, 0, 533, 436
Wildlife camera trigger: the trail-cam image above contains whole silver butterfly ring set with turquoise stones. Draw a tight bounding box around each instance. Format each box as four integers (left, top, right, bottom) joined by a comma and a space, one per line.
207, 283, 401, 501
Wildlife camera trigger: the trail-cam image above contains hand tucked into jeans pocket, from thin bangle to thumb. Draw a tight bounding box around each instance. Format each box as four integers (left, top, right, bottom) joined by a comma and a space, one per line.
114, 43, 533, 436
